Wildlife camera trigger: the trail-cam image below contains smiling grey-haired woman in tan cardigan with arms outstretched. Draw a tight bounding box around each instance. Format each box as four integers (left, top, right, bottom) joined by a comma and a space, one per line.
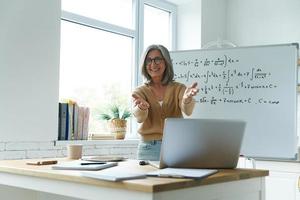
132, 45, 199, 160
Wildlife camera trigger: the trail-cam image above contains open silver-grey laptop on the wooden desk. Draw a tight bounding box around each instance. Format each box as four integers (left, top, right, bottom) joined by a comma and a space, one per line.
149, 118, 246, 169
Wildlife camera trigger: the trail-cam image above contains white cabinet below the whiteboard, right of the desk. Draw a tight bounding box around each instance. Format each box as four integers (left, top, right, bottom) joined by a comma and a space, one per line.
239, 158, 300, 200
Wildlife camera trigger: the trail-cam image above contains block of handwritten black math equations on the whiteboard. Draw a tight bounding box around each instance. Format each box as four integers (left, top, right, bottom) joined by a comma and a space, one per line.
173, 55, 279, 105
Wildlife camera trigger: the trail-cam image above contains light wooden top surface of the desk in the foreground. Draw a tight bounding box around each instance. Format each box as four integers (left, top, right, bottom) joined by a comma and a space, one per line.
0, 158, 269, 192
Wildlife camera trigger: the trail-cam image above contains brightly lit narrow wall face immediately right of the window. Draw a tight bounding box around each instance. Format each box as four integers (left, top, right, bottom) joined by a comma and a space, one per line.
177, 0, 201, 50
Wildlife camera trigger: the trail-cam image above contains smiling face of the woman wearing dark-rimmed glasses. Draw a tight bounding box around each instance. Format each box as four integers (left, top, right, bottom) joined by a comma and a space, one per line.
145, 50, 166, 80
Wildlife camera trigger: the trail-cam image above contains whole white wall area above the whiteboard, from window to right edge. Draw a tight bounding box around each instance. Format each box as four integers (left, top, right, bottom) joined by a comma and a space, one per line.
177, 0, 300, 49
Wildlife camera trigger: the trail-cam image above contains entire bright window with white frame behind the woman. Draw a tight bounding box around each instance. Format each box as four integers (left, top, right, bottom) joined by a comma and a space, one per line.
59, 0, 175, 137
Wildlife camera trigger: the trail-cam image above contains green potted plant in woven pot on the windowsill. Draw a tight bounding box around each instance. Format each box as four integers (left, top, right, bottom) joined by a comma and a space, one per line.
100, 105, 131, 140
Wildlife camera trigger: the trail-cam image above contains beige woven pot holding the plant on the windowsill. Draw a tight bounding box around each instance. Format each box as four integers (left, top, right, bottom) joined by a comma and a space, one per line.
109, 119, 127, 140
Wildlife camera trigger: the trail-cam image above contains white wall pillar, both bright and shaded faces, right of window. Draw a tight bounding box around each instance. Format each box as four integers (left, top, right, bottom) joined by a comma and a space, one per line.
177, 0, 227, 50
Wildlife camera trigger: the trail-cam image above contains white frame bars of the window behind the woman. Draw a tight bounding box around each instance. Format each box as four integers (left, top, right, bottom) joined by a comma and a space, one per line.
61, 0, 177, 138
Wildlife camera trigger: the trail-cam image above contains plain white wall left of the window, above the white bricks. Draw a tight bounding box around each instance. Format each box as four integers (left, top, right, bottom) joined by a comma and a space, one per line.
0, 0, 60, 141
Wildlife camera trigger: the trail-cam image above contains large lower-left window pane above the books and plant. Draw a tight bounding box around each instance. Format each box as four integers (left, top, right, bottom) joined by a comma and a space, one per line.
60, 21, 132, 133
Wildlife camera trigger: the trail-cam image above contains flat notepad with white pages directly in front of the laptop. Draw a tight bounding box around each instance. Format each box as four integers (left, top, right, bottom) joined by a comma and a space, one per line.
147, 168, 218, 179
